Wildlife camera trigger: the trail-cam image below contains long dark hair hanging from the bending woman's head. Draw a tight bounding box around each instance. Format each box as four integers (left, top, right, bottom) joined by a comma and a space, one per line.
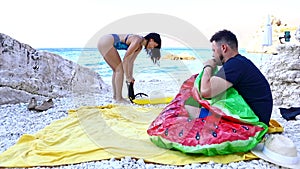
144, 33, 161, 64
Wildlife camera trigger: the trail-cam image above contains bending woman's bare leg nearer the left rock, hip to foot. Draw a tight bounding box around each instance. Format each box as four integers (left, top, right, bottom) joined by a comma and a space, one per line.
98, 35, 129, 103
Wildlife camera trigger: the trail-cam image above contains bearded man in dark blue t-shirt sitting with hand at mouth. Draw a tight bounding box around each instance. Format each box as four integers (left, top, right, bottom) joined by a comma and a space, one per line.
200, 30, 273, 125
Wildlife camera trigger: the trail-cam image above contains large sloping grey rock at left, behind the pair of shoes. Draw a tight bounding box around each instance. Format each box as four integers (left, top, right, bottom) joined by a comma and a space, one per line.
0, 33, 107, 105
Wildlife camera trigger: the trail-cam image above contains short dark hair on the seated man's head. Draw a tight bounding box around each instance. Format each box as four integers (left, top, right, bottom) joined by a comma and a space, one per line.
210, 29, 238, 49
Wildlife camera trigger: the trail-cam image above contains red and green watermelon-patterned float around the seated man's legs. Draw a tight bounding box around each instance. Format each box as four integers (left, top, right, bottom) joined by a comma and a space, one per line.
147, 73, 268, 156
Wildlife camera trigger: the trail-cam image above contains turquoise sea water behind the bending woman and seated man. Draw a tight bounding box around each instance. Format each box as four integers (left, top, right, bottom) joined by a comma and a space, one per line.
39, 48, 269, 84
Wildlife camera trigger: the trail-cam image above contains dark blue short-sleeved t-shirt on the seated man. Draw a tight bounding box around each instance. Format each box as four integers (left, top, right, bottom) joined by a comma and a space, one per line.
215, 54, 273, 125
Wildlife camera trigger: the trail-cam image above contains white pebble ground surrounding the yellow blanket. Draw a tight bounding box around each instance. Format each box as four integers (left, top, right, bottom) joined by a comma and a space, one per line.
0, 80, 300, 169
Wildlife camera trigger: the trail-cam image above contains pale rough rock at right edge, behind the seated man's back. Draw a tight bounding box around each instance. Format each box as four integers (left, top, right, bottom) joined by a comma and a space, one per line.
263, 44, 300, 107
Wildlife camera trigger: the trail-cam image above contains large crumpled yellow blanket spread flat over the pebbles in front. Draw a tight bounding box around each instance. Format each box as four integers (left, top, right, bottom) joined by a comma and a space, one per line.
0, 105, 282, 167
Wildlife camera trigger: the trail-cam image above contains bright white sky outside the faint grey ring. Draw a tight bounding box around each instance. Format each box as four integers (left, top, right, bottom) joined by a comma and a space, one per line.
0, 0, 300, 48
